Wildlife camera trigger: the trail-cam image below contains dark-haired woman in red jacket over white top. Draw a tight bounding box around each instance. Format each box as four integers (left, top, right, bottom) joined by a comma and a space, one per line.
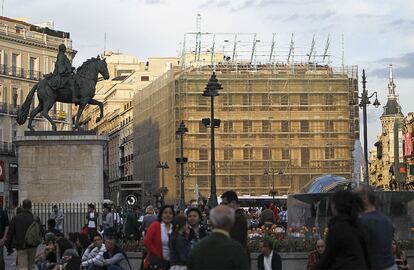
144, 205, 175, 270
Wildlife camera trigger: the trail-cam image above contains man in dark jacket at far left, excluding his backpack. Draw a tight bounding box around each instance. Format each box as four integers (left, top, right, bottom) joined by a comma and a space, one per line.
6, 199, 37, 269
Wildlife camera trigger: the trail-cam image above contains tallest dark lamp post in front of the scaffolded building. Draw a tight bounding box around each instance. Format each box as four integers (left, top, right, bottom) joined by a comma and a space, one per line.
201, 71, 223, 207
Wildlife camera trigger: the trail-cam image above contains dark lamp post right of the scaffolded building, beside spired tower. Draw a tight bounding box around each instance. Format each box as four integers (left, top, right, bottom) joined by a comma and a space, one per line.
358, 69, 381, 185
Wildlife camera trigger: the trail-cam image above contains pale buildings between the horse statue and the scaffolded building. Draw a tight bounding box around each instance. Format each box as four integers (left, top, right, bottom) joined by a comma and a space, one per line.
82, 52, 178, 203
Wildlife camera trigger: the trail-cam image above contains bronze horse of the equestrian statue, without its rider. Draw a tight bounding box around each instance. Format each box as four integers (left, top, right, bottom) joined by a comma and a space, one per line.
16, 56, 109, 130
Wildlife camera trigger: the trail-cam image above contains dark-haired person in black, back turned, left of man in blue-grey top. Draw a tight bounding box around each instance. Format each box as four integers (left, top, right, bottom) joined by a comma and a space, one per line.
316, 190, 370, 270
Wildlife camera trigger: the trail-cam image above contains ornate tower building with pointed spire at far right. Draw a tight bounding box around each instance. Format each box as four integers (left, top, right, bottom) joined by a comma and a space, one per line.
368, 65, 405, 190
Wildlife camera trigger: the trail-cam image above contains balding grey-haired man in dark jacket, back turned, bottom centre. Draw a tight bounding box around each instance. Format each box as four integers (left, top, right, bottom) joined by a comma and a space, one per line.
188, 205, 249, 270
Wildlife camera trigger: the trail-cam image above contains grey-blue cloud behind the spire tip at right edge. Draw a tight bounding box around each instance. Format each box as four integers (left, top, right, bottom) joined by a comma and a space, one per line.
370, 52, 414, 79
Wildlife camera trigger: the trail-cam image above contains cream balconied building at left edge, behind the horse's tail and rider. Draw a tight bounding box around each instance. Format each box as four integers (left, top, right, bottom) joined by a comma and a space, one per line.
0, 17, 76, 206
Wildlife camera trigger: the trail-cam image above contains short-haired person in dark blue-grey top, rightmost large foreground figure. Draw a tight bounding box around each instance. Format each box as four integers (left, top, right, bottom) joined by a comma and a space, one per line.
355, 185, 397, 270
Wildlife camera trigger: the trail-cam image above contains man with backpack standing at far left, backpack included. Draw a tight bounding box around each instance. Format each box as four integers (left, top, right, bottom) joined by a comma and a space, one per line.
6, 199, 42, 270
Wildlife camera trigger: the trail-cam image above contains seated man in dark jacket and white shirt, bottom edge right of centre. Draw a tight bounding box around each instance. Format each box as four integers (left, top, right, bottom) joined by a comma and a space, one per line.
257, 238, 282, 270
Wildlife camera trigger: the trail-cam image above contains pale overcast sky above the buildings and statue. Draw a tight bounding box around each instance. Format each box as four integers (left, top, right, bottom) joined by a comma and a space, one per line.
3, 0, 414, 148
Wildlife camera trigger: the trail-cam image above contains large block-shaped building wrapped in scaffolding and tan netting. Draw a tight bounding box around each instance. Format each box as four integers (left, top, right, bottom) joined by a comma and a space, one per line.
134, 33, 359, 203
